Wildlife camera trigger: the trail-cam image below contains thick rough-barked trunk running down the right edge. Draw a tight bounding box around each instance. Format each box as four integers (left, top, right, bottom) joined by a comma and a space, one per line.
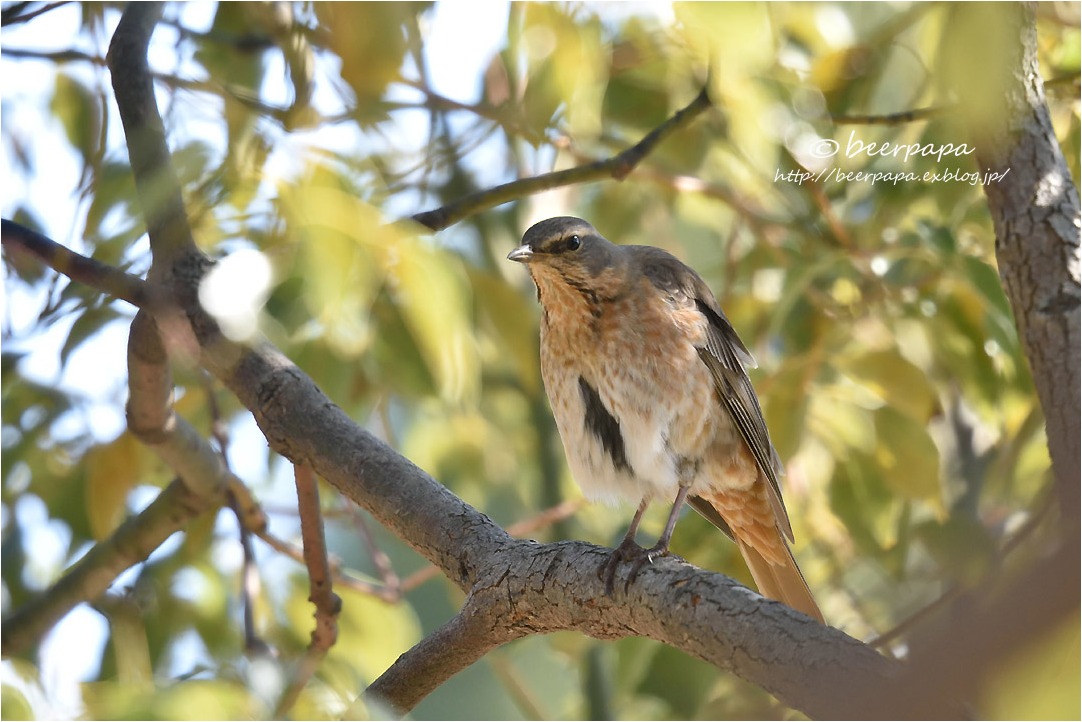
955, 3, 1082, 526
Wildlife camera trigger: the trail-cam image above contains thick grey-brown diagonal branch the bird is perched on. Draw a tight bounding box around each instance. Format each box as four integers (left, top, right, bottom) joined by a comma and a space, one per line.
192, 331, 896, 717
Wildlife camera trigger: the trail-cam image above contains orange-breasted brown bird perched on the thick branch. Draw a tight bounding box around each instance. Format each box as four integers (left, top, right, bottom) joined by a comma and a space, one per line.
507, 216, 823, 622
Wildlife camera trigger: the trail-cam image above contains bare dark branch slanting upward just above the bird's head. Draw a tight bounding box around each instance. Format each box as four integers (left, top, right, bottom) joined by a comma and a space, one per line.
411, 88, 711, 231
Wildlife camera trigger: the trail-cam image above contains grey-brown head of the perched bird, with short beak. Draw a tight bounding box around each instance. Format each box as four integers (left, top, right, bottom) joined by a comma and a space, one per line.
507, 215, 622, 285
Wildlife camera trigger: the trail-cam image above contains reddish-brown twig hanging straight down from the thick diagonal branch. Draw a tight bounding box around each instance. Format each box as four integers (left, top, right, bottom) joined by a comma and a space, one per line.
274, 464, 342, 719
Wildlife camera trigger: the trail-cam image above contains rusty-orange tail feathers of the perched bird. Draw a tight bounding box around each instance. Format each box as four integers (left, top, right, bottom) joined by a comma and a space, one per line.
688, 489, 823, 621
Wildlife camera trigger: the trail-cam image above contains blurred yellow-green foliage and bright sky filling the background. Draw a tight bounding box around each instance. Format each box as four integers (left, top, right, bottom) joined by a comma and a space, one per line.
0, 2, 1080, 719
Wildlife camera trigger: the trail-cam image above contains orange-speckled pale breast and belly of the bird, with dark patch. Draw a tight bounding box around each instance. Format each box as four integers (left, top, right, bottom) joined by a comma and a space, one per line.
538, 273, 748, 501
